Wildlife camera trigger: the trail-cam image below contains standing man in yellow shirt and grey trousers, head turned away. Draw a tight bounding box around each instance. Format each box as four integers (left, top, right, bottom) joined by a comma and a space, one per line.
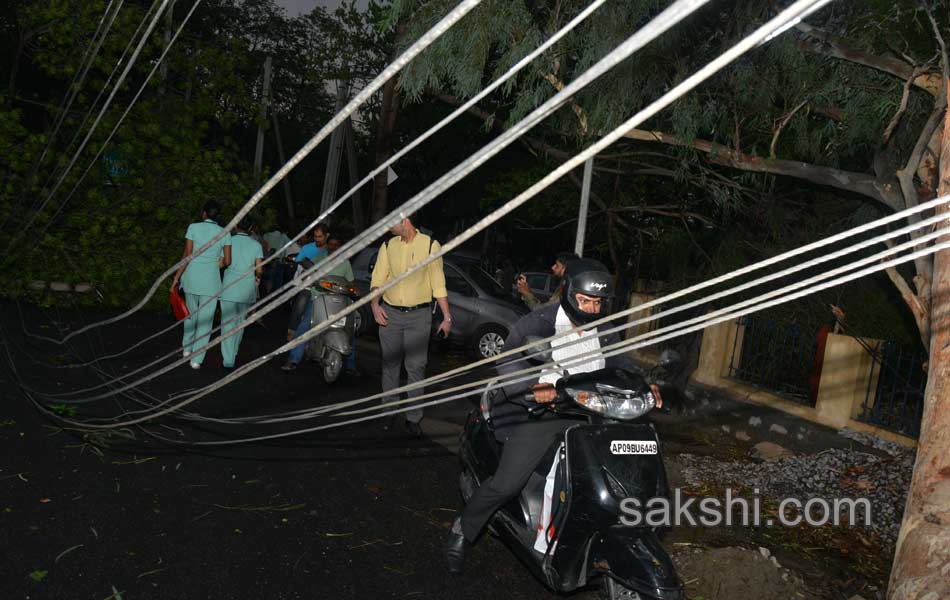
370, 217, 452, 437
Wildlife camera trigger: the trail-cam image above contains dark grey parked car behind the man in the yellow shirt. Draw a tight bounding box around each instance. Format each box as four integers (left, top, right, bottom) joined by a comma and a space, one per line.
351, 248, 528, 358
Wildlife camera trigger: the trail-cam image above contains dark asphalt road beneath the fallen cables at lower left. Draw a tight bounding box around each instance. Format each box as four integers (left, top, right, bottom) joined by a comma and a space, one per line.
0, 304, 584, 600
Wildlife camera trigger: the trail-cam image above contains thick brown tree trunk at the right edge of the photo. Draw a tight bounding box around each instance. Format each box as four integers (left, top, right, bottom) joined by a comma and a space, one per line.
888, 81, 950, 600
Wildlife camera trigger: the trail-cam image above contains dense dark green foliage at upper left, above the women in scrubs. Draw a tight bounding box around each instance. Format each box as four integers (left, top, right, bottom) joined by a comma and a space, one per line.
0, 0, 390, 308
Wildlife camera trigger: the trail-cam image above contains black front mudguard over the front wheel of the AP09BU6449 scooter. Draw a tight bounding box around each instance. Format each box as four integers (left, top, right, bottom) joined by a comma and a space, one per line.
589, 526, 685, 600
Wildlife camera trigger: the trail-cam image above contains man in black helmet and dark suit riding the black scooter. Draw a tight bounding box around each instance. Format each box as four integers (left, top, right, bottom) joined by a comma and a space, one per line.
445, 259, 662, 574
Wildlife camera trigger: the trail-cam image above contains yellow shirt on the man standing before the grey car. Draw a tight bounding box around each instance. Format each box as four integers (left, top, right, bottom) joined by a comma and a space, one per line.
370, 233, 448, 306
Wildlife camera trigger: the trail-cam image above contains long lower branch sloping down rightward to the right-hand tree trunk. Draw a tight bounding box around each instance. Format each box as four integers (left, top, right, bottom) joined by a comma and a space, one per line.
625, 129, 904, 211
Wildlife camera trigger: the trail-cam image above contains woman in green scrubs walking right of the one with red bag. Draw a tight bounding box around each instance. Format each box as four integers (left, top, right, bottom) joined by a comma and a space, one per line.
221, 217, 264, 369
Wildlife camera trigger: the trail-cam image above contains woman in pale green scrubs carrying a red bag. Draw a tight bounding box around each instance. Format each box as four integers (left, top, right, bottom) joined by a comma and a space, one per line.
172, 201, 231, 369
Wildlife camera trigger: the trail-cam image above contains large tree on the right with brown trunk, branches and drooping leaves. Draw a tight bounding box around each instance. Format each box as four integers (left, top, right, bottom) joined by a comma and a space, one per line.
390, 0, 950, 598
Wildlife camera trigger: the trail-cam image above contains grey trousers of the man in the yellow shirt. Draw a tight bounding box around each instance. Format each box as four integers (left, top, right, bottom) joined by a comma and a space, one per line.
379, 304, 432, 423
